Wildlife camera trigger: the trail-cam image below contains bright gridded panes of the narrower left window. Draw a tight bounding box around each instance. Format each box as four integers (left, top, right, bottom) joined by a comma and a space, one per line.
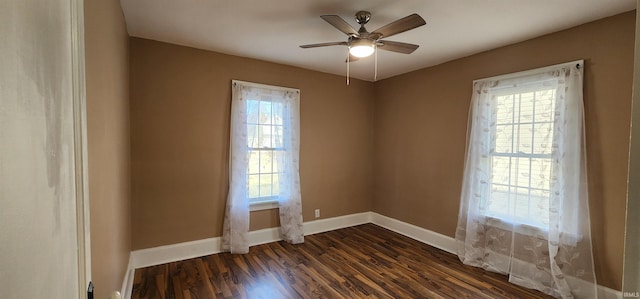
246, 97, 286, 202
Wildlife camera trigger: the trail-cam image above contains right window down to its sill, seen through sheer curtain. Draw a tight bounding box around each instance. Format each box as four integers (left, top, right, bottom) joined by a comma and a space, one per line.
458, 61, 589, 240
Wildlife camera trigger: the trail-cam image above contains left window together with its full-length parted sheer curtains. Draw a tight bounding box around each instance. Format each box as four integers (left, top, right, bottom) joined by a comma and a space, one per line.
221, 80, 304, 253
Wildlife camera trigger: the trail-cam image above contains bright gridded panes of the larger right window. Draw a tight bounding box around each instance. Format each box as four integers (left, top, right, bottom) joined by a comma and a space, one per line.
484, 84, 556, 227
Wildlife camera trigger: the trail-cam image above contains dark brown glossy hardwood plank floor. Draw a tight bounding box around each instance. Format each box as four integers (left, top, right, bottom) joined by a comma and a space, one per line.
132, 224, 552, 299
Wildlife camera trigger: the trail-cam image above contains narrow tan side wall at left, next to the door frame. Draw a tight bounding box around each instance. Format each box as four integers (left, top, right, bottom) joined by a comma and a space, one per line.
84, 0, 131, 298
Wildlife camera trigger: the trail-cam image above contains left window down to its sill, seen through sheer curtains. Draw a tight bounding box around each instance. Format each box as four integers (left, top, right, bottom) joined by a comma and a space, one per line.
231, 81, 300, 210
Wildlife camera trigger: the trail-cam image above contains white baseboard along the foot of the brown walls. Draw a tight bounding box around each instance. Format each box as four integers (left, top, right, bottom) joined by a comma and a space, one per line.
122, 212, 622, 299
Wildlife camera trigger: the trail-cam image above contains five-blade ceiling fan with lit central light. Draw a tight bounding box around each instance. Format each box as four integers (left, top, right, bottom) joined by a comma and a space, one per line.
300, 11, 426, 62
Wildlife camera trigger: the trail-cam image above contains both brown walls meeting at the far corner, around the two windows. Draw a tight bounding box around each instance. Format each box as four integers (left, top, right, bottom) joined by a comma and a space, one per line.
130, 12, 635, 290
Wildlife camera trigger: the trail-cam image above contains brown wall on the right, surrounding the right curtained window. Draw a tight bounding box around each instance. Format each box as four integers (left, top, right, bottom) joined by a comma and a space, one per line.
373, 12, 635, 290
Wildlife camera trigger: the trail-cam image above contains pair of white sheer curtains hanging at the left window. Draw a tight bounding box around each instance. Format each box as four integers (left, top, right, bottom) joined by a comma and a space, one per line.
222, 81, 304, 253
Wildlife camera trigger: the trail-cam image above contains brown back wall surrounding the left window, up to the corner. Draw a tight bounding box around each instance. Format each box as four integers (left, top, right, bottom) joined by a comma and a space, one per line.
130, 38, 373, 249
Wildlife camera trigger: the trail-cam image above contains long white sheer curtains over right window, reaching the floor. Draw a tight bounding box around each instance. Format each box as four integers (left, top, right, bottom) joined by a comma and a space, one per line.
456, 63, 597, 298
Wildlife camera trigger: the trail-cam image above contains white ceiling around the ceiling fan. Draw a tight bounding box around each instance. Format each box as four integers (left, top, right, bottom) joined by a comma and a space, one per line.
121, 0, 636, 81
